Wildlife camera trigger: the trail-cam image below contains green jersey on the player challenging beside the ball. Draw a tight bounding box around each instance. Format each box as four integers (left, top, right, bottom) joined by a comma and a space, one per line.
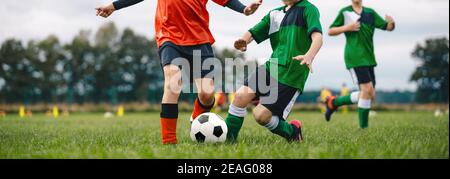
249, 0, 322, 91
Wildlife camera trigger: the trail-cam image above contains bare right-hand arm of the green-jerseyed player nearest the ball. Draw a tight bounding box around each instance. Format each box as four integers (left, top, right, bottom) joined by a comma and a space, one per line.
292, 32, 323, 73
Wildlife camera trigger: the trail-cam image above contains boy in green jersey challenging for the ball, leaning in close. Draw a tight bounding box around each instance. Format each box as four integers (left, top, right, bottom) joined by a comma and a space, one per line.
225, 0, 322, 142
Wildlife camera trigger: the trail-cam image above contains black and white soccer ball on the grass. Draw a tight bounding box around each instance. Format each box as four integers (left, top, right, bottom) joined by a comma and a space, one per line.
191, 113, 228, 143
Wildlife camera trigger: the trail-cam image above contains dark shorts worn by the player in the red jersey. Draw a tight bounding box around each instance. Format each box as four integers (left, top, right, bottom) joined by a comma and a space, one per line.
158, 42, 215, 81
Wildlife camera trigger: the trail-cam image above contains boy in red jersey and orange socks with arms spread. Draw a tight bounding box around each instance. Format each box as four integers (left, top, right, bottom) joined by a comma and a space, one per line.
96, 0, 262, 144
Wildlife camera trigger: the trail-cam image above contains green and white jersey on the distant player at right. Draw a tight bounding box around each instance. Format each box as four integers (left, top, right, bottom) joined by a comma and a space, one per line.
331, 6, 388, 69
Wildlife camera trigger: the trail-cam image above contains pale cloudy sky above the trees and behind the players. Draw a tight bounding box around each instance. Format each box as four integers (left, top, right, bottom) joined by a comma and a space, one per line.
0, 0, 449, 90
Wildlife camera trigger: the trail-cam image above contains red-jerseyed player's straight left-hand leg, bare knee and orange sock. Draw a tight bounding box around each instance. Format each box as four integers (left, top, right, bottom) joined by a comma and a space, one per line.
161, 65, 181, 144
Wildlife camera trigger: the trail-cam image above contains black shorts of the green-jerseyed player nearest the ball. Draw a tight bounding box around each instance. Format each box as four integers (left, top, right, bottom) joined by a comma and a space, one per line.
244, 66, 301, 120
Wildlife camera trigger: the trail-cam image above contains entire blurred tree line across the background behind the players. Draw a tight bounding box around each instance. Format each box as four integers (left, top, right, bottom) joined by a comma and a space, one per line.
0, 23, 449, 104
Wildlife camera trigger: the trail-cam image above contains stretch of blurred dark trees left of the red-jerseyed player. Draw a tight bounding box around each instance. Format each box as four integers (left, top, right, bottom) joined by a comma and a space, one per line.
0, 23, 163, 104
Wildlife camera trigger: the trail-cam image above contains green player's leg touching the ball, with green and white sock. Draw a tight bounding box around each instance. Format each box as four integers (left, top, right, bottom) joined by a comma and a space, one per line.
225, 86, 256, 142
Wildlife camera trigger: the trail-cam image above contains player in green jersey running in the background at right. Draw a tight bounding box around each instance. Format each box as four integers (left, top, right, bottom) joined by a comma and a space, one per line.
325, 0, 395, 129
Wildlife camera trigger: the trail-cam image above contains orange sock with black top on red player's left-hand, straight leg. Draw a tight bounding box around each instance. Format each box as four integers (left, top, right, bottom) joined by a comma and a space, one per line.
161, 104, 178, 144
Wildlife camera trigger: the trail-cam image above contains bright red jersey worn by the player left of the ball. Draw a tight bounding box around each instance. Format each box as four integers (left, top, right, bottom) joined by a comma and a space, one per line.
155, 0, 229, 47
